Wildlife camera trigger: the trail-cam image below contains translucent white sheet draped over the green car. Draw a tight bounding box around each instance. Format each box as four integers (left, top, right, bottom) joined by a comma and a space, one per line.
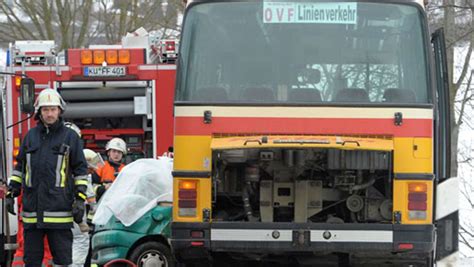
93, 157, 173, 226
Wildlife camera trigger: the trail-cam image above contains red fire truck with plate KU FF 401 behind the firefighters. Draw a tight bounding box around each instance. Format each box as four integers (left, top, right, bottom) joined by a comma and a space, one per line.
6, 35, 177, 170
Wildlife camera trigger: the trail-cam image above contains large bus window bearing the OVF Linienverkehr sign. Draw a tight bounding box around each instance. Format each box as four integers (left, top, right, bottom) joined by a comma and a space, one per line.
176, 1, 431, 105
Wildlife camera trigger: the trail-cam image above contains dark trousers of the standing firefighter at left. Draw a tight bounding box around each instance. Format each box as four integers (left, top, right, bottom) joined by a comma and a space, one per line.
24, 229, 72, 267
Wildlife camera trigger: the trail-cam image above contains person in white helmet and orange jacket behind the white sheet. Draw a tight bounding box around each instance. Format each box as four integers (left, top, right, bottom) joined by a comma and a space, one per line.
92, 137, 127, 200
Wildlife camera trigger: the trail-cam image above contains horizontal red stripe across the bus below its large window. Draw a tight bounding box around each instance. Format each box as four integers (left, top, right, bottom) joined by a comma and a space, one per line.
175, 117, 433, 137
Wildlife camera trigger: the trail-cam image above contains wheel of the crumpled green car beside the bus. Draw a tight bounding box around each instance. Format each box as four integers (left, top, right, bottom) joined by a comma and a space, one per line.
129, 241, 175, 267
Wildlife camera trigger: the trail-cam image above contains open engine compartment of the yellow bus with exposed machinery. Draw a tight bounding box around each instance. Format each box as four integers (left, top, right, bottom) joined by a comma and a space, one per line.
212, 147, 393, 223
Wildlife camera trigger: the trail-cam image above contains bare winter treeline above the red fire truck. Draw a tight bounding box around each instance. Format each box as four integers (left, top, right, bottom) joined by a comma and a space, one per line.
0, 0, 184, 50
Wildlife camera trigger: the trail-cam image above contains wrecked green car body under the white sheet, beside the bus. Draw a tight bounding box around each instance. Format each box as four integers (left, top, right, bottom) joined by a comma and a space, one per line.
92, 203, 175, 267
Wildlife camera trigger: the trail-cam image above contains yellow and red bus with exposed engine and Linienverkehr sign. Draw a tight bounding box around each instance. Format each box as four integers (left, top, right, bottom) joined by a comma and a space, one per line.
171, 0, 458, 266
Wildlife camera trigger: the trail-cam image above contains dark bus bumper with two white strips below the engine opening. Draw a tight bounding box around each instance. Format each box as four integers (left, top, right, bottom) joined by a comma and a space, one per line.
171, 222, 435, 259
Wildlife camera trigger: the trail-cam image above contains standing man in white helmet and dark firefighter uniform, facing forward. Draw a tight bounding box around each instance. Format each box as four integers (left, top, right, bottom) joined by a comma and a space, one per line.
8, 88, 87, 267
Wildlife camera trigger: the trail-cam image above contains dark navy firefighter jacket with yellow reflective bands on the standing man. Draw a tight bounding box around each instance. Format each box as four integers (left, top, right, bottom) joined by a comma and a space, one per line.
10, 118, 87, 229
